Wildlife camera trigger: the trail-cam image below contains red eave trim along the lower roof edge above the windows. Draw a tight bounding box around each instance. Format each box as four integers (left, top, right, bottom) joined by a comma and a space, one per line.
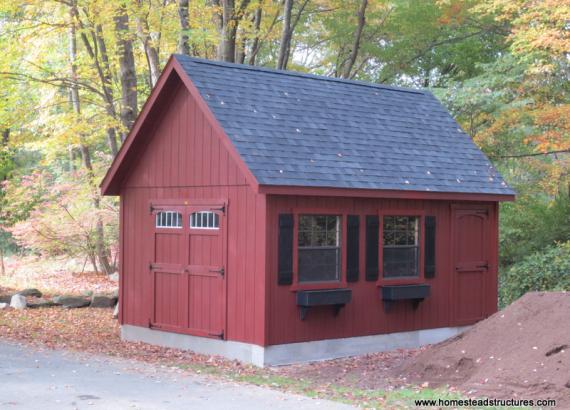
259, 185, 515, 202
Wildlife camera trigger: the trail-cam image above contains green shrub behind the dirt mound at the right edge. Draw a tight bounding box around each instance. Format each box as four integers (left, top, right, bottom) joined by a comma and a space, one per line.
499, 242, 570, 307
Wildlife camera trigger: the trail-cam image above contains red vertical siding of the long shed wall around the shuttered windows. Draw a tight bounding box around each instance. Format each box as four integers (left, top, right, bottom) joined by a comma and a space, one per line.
266, 196, 497, 345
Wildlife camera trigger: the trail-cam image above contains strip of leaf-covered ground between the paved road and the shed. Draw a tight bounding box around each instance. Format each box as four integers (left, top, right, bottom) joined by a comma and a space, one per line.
0, 307, 457, 408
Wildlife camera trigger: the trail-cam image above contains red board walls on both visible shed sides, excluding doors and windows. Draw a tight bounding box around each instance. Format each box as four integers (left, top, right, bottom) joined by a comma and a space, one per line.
115, 68, 498, 345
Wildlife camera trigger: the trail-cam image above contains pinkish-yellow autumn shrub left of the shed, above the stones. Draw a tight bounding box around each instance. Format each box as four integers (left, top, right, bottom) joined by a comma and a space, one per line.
0, 171, 118, 273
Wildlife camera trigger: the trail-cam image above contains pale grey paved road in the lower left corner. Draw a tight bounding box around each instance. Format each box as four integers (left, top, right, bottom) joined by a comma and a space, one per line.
0, 341, 351, 410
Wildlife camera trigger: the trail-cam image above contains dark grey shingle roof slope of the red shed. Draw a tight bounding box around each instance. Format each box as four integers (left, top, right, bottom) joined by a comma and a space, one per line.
175, 55, 514, 195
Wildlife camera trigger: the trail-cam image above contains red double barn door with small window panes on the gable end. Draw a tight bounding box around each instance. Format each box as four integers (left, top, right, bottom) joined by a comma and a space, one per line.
149, 202, 226, 339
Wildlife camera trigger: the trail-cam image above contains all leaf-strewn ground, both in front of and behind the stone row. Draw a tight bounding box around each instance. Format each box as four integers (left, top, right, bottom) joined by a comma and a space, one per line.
0, 257, 466, 409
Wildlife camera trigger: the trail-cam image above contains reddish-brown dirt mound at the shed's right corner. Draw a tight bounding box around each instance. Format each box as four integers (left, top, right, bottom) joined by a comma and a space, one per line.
394, 292, 570, 408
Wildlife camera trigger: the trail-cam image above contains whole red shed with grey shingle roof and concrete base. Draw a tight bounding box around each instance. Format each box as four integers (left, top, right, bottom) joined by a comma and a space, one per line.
102, 55, 514, 365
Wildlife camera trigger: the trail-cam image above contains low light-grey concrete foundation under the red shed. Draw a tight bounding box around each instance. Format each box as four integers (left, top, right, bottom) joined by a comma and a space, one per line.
121, 325, 469, 367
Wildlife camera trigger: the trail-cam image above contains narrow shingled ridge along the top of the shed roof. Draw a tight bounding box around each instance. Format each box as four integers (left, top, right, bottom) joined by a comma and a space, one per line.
173, 54, 426, 95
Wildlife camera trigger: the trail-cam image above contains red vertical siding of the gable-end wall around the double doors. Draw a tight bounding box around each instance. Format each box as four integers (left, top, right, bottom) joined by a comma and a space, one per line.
121, 78, 266, 345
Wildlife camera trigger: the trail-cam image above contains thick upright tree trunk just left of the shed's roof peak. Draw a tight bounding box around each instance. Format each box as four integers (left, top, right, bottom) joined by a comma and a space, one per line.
114, 5, 138, 141
